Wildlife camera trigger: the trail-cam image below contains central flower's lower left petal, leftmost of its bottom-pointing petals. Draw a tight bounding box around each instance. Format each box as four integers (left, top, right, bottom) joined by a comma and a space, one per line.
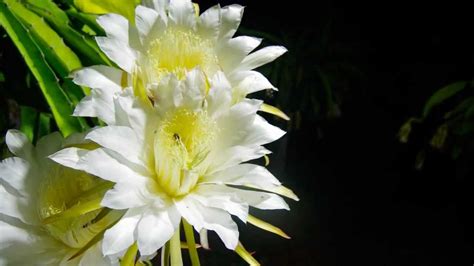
102, 208, 142, 256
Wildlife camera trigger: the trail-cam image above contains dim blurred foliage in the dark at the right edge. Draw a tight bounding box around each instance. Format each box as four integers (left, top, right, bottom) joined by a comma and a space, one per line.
399, 81, 474, 169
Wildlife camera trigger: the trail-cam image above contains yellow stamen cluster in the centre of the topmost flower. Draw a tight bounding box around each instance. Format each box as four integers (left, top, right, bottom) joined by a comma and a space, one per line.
147, 28, 218, 80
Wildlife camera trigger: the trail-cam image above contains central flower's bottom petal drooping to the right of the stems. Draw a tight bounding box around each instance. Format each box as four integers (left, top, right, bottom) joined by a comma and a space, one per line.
176, 198, 239, 250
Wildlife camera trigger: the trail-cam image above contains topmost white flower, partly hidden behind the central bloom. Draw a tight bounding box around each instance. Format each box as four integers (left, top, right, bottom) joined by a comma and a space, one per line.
70, 0, 286, 124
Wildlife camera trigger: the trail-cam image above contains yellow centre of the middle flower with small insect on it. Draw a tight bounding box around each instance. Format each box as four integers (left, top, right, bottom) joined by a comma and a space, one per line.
154, 109, 218, 197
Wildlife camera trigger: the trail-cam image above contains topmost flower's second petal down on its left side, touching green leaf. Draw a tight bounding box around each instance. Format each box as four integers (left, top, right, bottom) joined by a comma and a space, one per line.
95, 37, 137, 73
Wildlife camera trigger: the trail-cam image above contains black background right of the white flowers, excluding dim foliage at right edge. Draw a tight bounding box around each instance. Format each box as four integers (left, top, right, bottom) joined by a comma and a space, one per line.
0, 0, 474, 265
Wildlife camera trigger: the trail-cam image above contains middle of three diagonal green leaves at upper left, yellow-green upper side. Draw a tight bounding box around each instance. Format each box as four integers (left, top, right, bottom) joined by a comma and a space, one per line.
5, 0, 88, 101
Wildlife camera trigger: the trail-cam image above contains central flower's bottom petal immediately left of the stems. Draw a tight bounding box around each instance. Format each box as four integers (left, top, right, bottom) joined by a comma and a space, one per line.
137, 206, 181, 256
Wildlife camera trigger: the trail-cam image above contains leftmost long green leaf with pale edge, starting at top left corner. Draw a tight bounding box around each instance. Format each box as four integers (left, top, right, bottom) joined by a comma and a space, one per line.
0, 2, 82, 136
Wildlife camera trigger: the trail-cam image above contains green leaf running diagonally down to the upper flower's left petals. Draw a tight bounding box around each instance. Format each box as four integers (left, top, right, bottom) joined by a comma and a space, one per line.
24, 0, 112, 65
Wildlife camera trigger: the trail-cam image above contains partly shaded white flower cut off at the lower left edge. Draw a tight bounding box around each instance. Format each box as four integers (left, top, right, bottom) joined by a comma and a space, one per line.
0, 130, 119, 265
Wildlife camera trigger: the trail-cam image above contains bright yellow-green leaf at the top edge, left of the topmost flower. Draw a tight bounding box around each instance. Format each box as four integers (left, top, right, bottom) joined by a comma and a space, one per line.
74, 0, 137, 21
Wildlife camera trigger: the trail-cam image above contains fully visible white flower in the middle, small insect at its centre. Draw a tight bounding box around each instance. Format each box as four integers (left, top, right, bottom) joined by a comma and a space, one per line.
51, 69, 297, 256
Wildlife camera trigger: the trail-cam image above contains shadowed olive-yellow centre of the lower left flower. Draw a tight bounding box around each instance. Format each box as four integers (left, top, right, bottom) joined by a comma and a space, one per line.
38, 165, 110, 248
